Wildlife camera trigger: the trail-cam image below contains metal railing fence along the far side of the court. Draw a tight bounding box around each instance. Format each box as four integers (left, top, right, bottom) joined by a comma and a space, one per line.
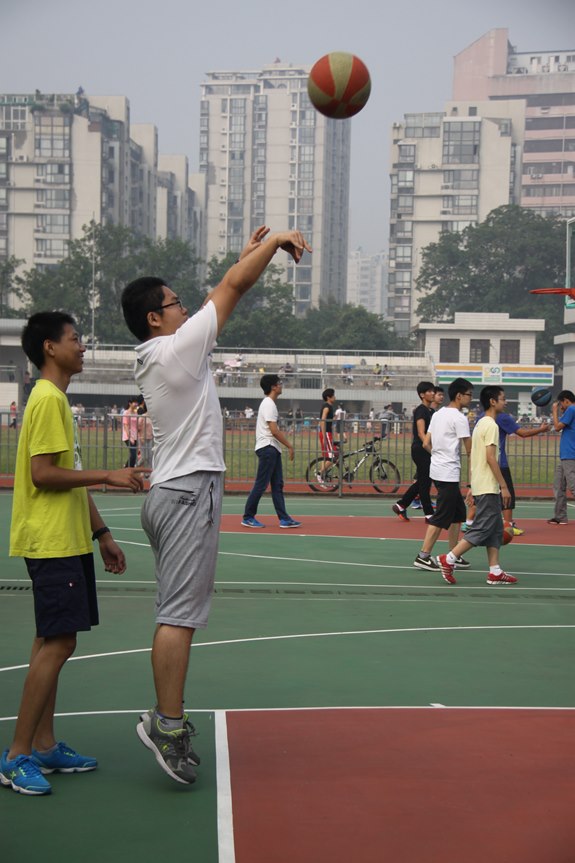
0, 413, 559, 497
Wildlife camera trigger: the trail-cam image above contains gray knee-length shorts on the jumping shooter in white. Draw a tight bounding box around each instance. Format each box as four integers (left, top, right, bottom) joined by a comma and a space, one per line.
142, 471, 223, 629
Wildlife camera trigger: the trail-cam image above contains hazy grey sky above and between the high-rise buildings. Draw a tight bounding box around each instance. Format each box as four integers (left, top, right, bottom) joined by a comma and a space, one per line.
0, 0, 575, 253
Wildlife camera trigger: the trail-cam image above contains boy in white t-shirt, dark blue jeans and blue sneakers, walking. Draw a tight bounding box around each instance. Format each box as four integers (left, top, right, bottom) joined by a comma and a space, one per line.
242, 375, 301, 528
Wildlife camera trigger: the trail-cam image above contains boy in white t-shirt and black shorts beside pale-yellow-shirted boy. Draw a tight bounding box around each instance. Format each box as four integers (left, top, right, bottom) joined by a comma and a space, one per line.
413, 378, 473, 572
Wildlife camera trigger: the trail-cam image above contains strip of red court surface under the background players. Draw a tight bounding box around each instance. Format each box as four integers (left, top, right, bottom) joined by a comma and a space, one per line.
221, 512, 575, 548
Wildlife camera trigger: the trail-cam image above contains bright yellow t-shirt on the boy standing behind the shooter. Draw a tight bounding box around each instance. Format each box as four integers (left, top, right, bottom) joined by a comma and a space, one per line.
10, 380, 92, 558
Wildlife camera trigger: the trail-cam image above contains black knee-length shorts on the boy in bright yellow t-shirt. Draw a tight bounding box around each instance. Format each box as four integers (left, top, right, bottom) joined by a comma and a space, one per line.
25, 554, 99, 638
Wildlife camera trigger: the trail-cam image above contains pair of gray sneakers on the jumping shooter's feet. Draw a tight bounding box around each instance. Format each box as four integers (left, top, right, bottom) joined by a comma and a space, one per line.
136, 710, 200, 785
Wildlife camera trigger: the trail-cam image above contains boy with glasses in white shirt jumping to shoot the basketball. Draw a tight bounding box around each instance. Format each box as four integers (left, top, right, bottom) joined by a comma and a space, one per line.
122, 225, 311, 784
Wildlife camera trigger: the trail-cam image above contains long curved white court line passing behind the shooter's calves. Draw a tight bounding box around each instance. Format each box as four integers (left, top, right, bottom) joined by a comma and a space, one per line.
0, 623, 575, 673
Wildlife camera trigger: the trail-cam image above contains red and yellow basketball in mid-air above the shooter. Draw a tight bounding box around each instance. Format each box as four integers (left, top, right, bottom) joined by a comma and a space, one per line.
307, 51, 371, 120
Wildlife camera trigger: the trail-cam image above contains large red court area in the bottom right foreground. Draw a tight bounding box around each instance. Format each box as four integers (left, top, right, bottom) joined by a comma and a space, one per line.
227, 707, 575, 863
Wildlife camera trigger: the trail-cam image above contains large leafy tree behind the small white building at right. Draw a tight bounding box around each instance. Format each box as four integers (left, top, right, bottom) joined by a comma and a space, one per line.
417, 205, 565, 362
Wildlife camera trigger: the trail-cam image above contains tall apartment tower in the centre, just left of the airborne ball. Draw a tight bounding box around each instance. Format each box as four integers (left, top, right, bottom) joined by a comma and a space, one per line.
200, 61, 350, 314
